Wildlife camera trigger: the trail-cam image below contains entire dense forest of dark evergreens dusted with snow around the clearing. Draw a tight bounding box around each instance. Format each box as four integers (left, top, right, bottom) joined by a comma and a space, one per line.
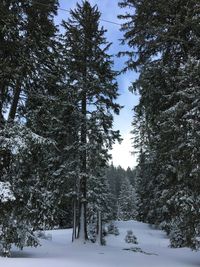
0, 0, 200, 255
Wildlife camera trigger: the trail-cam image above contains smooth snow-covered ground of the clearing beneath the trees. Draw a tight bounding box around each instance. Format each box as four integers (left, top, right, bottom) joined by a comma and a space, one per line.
0, 221, 200, 267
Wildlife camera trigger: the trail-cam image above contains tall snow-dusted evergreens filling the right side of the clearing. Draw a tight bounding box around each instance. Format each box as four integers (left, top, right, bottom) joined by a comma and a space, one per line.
120, 0, 200, 248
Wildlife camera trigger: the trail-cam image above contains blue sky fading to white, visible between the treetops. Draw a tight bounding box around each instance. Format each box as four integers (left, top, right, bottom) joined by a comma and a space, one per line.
56, 0, 139, 168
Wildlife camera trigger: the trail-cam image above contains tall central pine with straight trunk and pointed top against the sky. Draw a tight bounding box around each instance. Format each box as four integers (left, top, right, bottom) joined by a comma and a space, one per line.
63, 1, 120, 243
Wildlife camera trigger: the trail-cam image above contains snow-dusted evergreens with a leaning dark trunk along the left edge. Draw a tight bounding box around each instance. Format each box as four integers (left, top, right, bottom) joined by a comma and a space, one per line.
0, 1, 57, 254
